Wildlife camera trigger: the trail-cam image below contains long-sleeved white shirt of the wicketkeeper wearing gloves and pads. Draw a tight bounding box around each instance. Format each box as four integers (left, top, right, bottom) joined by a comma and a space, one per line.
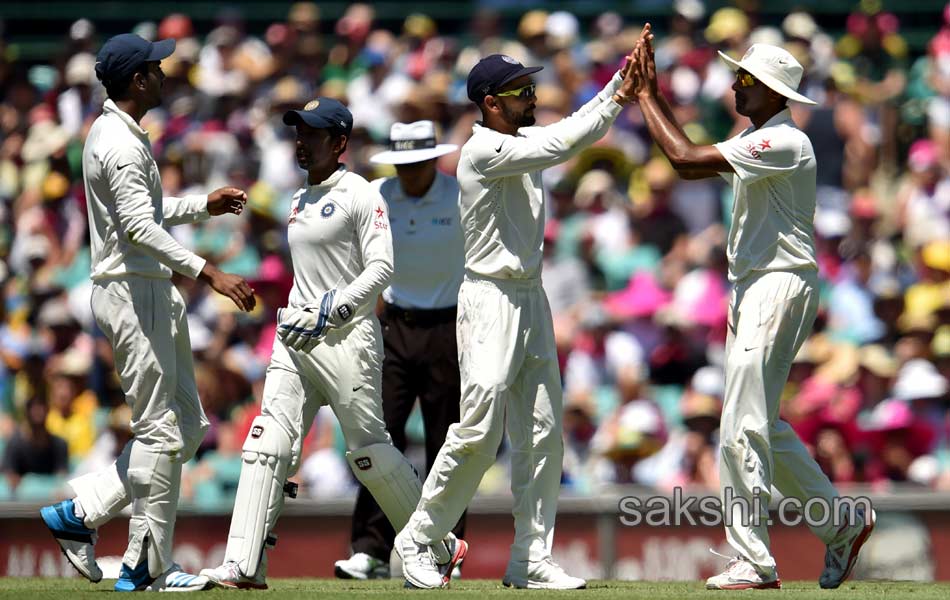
287, 164, 393, 323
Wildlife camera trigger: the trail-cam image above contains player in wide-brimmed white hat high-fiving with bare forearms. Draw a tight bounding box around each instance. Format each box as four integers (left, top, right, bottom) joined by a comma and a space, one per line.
633, 25, 874, 589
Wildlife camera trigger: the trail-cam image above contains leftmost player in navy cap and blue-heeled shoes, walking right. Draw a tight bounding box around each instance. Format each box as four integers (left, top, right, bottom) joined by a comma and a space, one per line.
41, 34, 254, 591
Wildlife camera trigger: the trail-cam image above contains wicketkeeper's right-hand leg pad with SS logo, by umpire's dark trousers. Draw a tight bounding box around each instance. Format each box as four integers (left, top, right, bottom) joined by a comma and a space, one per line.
346, 444, 422, 531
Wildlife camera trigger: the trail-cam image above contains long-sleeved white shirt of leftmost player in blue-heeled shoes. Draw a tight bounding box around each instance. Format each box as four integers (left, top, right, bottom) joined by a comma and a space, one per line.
82, 100, 208, 281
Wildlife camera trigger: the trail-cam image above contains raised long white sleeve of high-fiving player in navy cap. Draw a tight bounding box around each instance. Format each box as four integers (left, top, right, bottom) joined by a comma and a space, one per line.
467, 99, 622, 179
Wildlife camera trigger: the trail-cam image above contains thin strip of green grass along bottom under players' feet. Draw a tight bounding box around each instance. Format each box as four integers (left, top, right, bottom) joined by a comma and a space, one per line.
0, 577, 950, 600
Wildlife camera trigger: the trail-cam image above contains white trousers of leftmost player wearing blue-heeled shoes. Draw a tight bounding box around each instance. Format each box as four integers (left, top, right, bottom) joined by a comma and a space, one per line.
70, 275, 209, 577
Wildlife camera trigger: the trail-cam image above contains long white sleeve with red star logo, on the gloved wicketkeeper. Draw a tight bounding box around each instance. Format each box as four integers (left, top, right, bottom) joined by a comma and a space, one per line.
339, 185, 393, 308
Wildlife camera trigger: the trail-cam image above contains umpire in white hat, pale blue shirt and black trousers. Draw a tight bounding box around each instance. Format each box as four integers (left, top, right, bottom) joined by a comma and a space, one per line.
334, 121, 465, 579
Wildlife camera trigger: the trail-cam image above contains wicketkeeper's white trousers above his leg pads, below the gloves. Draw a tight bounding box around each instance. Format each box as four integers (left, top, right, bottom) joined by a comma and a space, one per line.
261, 316, 392, 477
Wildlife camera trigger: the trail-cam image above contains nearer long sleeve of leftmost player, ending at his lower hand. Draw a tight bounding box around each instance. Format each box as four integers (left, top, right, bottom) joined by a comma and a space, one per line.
102, 148, 205, 279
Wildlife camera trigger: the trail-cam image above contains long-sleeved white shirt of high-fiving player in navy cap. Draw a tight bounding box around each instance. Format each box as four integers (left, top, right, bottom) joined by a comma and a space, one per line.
458, 73, 622, 279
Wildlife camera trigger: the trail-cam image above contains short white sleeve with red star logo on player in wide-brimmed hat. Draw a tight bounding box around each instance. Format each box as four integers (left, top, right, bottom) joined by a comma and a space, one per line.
715, 128, 802, 183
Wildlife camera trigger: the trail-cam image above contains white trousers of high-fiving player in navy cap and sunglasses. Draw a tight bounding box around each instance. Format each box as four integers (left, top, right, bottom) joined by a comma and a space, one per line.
407, 275, 564, 561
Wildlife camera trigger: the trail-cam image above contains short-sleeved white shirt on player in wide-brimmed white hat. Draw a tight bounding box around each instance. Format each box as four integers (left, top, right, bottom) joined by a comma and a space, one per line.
716, 109, 818, 282
